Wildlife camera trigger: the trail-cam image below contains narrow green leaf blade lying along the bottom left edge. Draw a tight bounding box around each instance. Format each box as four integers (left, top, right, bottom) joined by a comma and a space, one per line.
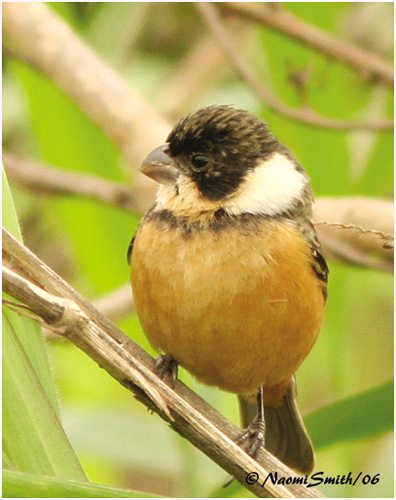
3, 470, 158, 498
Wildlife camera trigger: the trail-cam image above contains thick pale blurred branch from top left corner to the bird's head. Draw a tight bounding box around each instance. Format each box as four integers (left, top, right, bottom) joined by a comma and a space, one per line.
2, 2, 161, 209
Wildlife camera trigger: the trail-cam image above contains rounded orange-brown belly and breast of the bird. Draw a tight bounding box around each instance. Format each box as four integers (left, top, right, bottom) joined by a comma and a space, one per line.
131, 217, 324, 394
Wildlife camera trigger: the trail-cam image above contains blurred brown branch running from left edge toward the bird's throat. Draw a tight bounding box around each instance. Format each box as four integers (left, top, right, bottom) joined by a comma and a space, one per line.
3, 153, 139, 212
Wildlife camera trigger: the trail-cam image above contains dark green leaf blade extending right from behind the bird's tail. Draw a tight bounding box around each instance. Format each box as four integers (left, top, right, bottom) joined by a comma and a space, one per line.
305, 381, 393, 450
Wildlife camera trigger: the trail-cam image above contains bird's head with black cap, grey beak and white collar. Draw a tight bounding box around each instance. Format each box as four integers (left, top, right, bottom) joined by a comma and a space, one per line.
140, 106, 311, 216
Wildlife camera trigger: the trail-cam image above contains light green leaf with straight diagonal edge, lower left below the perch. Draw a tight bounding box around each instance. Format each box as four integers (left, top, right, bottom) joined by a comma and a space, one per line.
3, 315, 85, 480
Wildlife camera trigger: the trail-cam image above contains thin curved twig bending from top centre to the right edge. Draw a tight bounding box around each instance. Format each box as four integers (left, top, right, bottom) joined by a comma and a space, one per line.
196, 2, 393, 130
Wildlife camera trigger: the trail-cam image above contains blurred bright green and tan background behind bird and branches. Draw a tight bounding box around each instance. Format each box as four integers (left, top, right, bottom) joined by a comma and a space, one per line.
3, 2, 393, 498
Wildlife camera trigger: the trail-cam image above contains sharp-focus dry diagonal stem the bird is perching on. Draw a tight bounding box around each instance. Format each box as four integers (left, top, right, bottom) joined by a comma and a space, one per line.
3, 229, 322, 498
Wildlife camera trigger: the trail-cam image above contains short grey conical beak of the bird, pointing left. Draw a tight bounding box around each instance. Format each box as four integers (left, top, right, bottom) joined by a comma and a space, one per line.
139, 143, 180, 184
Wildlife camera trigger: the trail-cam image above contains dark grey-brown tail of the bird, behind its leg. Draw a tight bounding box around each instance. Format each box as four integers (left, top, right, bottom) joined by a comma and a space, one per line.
238, 377, 315, 474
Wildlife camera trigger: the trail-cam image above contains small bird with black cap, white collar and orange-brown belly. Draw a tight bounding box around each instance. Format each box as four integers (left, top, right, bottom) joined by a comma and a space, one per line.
128, 105, 328, 474
